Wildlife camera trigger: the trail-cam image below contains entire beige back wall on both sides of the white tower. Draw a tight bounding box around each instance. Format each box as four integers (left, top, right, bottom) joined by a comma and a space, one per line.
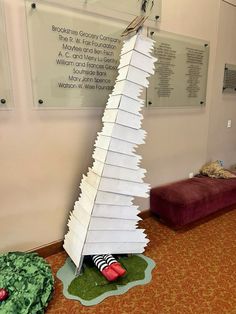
0, 0, 225, 251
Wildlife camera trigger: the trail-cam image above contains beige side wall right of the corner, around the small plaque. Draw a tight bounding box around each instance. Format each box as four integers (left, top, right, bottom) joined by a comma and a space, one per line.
208, 2, 236, 167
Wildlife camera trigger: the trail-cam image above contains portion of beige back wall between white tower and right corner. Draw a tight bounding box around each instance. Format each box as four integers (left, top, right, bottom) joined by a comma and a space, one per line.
136, 0, 220, 208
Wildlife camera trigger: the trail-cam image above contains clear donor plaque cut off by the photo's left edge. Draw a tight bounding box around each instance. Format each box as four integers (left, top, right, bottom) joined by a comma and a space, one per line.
0, 1, 13, 109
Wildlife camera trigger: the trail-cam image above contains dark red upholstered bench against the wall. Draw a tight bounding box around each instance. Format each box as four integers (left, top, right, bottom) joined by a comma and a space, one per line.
150, 176, 236, 228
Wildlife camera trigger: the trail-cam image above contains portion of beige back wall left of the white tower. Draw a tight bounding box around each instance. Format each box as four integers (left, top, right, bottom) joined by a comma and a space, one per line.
0, 0, 103, 251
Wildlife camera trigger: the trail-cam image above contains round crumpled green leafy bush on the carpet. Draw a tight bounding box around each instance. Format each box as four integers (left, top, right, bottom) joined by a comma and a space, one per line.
0, 252, 54, 314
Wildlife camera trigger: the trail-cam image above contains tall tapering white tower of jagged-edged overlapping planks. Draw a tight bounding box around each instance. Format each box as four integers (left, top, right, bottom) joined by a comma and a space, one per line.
64, 34, 156, 268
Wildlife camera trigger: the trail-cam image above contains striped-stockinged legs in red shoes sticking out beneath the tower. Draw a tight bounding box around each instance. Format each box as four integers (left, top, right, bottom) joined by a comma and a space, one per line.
92, 254, 126, 281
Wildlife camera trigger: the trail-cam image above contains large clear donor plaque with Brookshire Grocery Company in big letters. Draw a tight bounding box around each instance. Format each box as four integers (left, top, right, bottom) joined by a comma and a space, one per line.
25, 0, 125, 108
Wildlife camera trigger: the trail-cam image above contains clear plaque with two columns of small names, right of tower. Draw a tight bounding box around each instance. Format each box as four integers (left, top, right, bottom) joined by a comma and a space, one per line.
147, 29, 209, 108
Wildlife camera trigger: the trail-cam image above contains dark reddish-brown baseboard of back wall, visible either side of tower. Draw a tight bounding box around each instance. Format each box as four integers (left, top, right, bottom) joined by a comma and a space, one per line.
31, 210, 152, 258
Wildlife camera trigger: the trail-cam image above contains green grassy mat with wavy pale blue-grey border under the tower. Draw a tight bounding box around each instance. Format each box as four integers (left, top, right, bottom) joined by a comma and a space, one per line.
57, 254, 156, 306
